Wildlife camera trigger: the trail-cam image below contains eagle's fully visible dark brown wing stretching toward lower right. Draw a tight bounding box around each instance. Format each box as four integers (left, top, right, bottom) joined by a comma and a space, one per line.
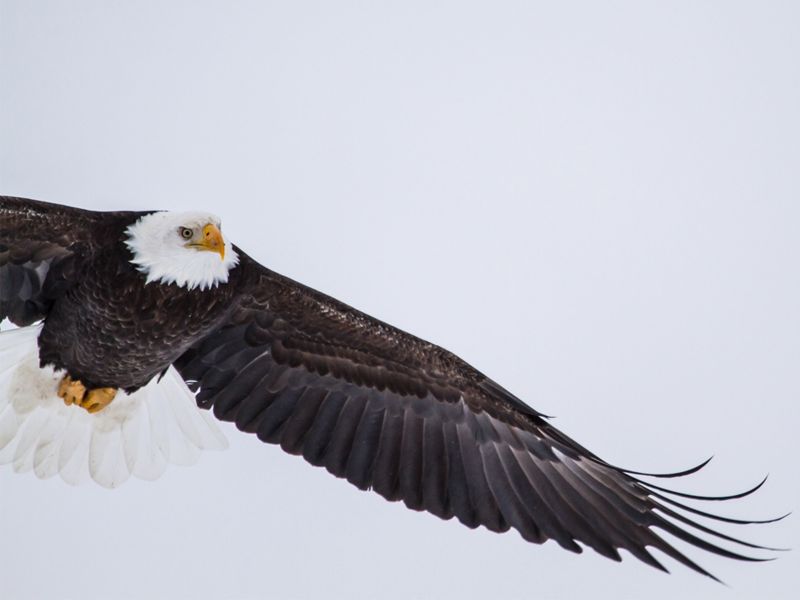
175, 254, 780, 574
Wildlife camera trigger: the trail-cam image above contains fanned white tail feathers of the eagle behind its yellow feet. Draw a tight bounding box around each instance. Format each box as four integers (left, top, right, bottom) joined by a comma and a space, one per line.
0, 325, 228, 488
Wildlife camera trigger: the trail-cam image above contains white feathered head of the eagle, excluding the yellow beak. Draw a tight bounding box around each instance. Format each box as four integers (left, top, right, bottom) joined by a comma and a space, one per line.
125, 212, 239, 290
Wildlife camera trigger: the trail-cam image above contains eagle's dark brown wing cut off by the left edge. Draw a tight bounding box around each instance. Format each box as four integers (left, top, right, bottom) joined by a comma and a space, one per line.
0, 196, 127, 326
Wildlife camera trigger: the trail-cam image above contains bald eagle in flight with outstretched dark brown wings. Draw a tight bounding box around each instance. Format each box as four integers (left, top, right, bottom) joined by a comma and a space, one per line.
0, 197, 776, 577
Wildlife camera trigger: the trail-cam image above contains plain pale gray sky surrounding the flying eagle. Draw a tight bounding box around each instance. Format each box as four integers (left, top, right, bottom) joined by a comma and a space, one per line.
0, 0, 800, 599
